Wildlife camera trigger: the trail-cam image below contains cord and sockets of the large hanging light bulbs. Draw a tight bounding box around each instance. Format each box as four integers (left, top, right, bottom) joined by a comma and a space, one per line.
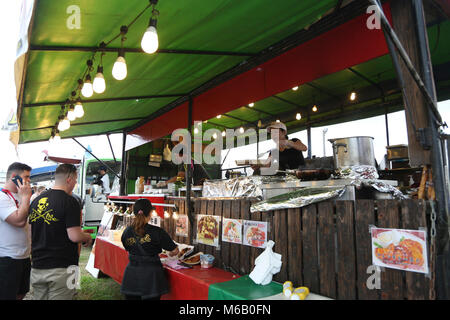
50, 0, 159, 141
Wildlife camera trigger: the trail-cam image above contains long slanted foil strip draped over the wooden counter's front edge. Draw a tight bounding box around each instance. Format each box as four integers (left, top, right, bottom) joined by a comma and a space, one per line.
250, 186, 345, 213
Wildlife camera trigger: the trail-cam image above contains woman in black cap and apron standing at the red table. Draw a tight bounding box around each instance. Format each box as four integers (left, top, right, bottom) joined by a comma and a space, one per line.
120, 199, 178, 300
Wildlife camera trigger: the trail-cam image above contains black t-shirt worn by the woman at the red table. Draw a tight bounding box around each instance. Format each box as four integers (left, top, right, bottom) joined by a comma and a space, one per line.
121, 224, 177, 256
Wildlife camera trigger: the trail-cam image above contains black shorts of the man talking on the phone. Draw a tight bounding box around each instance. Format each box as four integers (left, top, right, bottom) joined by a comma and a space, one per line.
0, 257, 31, 300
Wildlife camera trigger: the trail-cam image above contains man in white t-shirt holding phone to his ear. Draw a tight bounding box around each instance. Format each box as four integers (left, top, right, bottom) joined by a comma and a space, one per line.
0, 162, 31, 300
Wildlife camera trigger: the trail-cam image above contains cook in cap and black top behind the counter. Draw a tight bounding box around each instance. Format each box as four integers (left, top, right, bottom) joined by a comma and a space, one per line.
252, 122, 308, 174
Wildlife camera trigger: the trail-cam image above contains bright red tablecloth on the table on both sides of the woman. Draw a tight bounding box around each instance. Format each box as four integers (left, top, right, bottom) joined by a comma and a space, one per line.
94, 237, 239, 300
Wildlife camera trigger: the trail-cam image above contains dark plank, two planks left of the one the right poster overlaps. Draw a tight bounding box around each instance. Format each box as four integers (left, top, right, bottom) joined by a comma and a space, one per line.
317, 201, 336, 299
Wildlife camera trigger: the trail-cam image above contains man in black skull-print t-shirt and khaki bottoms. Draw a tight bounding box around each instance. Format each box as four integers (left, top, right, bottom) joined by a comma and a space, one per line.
29, 164, 92, 300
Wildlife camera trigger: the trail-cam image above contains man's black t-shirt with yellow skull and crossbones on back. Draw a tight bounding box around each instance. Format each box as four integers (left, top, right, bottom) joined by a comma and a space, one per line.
28, 189, 81, 269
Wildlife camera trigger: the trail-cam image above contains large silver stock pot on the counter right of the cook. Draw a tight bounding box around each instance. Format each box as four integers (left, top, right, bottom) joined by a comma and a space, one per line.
328, 137, 375, 169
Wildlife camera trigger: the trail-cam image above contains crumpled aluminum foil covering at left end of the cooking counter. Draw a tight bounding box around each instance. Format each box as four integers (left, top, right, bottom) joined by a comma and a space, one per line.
202, 175, 299, 199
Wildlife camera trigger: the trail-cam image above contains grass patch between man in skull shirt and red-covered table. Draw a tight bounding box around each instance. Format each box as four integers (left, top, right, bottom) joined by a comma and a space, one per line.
75, 242, 124, 300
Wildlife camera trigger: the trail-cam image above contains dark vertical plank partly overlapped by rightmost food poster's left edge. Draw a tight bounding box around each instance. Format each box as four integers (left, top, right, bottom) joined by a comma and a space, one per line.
355, 200, 380, 300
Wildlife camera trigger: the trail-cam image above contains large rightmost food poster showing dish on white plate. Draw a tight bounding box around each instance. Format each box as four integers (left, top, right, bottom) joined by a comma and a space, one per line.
371, 228, 428, 274
